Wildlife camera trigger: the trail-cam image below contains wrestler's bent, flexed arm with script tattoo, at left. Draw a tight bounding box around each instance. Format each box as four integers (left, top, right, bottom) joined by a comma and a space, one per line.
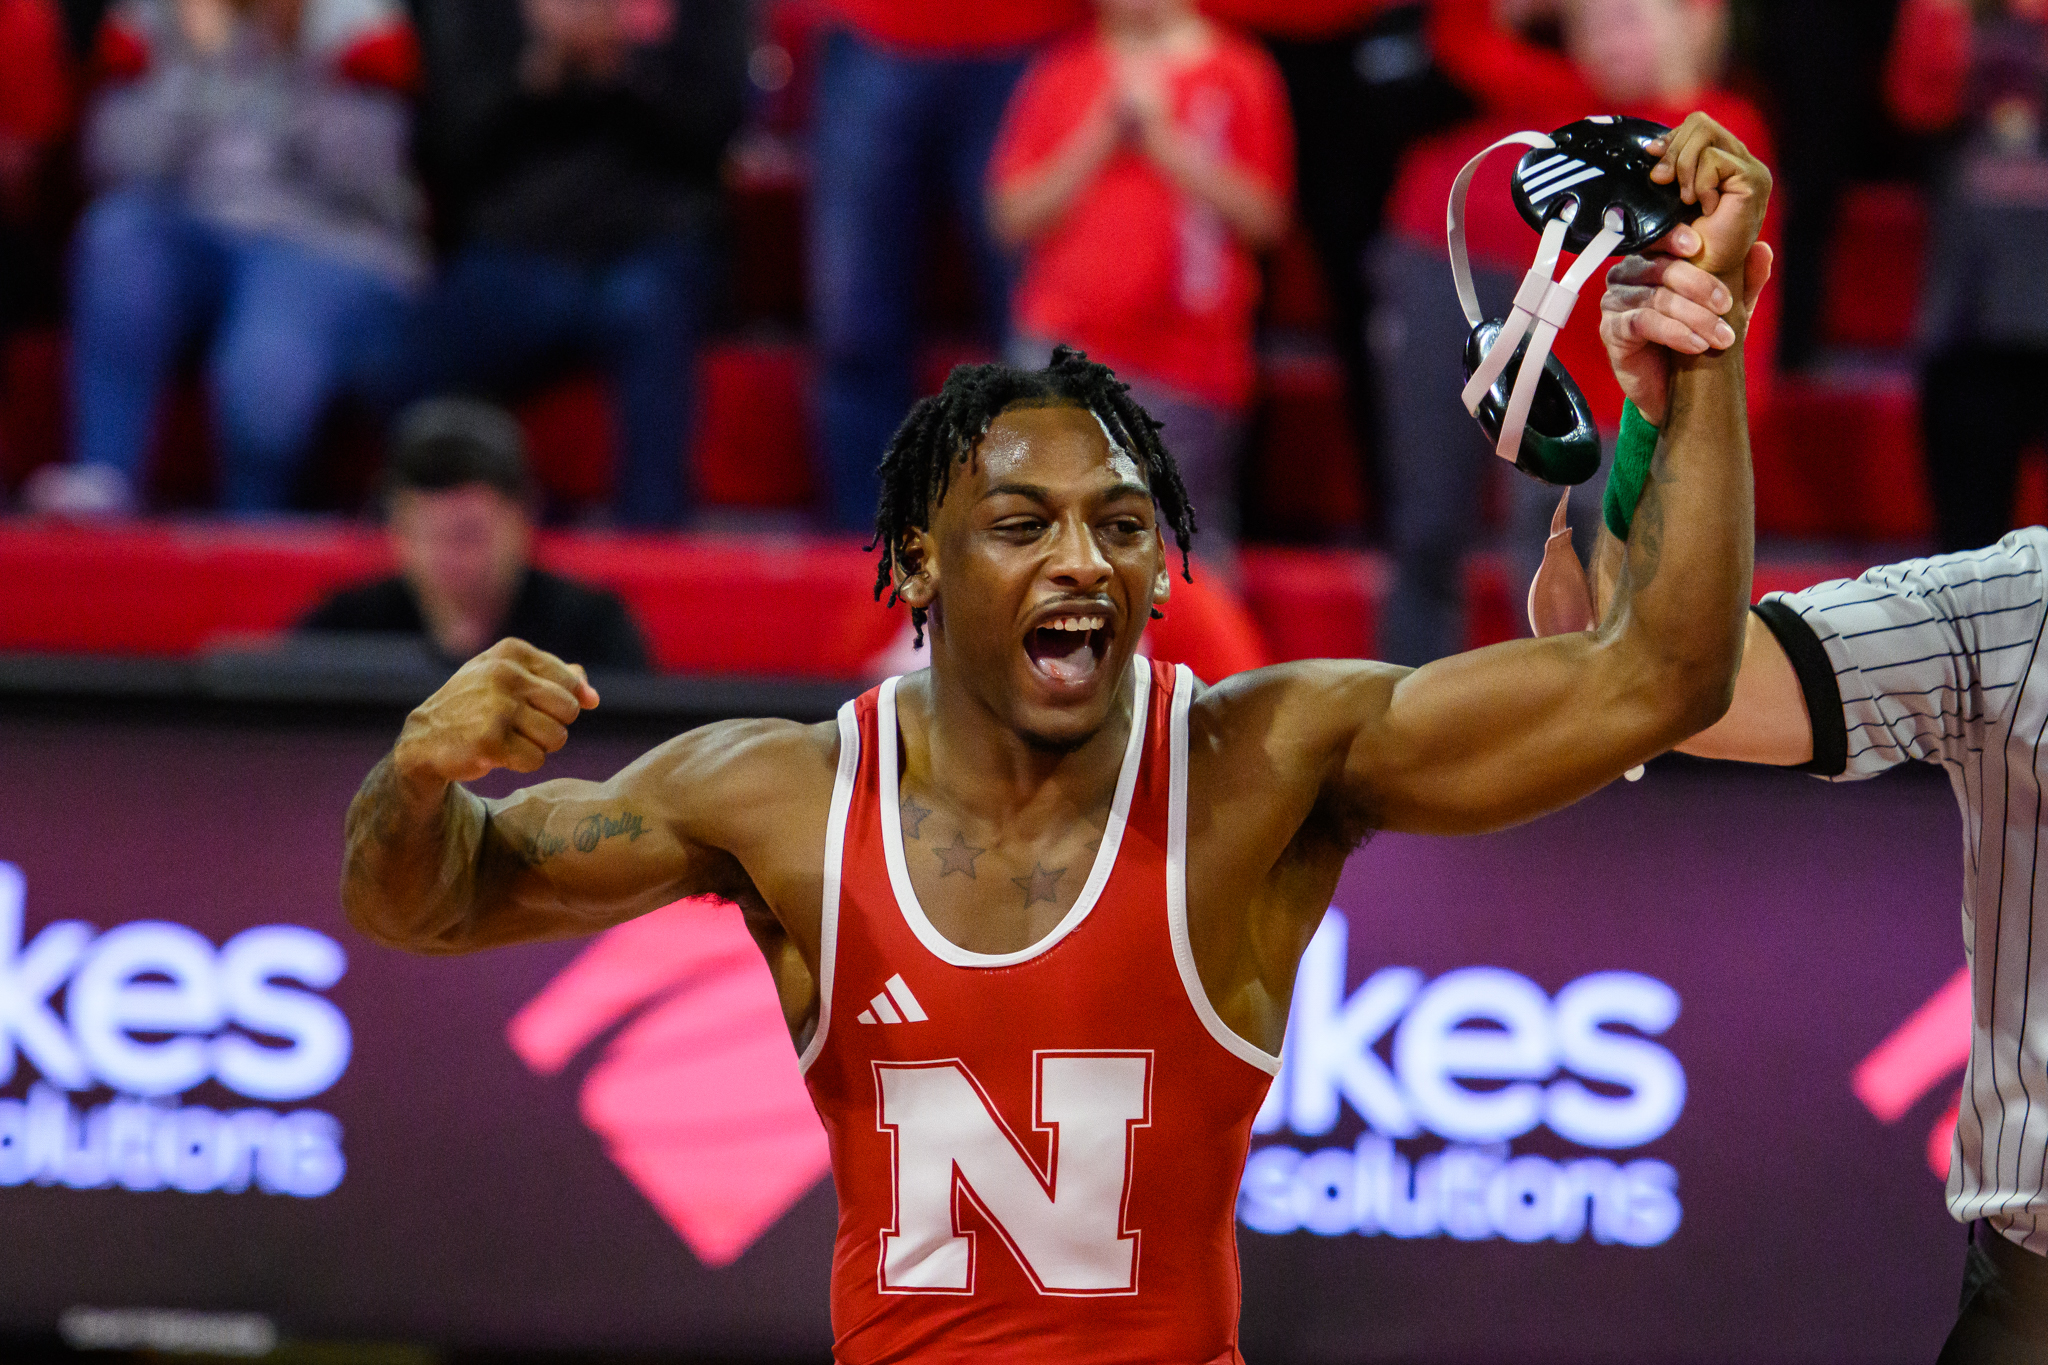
342, 641, 834, 952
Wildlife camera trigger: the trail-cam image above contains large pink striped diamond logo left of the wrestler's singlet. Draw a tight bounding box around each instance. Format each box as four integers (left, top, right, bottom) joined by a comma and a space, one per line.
506, 898, 831, 1267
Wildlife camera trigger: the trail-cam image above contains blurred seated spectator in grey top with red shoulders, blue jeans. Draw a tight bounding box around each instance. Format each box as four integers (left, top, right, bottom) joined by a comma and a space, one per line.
27, 0, 424, 514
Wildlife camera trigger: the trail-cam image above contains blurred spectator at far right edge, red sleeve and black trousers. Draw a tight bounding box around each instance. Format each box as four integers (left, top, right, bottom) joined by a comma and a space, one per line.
1864, 0, 2048, 551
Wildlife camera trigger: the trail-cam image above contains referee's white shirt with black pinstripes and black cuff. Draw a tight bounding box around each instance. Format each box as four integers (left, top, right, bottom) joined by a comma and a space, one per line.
1757, 526, 2048, 1252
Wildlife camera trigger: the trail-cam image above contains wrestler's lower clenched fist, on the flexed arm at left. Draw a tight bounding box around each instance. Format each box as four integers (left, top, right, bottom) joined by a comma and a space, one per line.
391, 639, 598, 784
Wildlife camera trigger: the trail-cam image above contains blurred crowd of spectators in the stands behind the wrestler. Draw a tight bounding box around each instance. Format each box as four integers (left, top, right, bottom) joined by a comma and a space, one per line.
0, 0, 2048, 663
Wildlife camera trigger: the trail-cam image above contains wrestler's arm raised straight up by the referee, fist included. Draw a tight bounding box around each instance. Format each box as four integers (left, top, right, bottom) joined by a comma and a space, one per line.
1225, 115, 1772, 833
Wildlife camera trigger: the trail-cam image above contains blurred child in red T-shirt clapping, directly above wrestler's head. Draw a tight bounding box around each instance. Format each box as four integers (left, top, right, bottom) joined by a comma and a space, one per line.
989, 0, 1294, 563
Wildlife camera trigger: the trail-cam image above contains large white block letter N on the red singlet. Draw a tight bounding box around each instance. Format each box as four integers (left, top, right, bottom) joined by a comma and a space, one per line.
874, 1052, 1151, 1293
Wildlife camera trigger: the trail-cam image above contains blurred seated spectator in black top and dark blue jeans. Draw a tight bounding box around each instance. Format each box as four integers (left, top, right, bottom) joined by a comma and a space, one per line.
410, 0, 748, 526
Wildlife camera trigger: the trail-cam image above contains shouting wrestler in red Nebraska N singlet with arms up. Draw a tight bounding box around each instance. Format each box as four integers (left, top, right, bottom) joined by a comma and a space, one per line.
342, 117, 1772, 1365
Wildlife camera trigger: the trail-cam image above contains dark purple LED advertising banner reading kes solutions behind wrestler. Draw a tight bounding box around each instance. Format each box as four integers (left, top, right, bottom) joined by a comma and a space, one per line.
0, 718, 1968, 1363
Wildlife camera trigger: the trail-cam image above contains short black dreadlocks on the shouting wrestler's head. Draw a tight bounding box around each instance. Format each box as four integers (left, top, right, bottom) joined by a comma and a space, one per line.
868, 346, 1194, 645
